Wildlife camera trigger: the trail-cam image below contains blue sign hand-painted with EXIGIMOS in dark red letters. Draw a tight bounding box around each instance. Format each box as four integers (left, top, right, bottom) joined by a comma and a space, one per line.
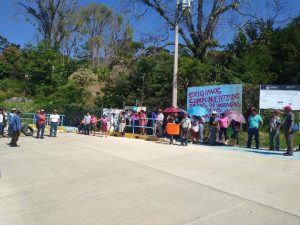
187, 84, 243, 119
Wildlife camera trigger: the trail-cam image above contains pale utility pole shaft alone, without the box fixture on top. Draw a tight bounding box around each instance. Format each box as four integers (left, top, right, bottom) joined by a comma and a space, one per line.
172, 0, 180, 107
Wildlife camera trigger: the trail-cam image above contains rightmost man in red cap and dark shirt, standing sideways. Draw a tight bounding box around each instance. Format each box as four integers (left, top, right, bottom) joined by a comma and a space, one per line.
283, 106, 295, 156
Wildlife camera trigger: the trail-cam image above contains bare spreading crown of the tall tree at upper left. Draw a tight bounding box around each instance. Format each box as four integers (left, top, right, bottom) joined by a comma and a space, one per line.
18, 0, 77, 47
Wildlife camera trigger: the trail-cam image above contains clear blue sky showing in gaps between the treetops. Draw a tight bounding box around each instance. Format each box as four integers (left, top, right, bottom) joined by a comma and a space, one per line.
0, 0, 300, 46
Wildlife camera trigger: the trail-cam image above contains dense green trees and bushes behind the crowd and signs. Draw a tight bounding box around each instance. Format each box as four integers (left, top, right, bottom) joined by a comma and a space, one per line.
0, 0, 300, 125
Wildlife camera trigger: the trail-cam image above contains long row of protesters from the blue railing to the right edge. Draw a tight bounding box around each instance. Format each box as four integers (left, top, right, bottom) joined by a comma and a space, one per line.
74, 106, 296, 156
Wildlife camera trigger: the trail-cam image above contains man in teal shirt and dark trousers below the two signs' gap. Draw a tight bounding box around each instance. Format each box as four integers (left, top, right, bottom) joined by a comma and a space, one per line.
247, 109, 264, 149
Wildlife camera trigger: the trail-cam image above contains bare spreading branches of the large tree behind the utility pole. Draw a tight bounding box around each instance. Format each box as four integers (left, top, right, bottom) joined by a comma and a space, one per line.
129, 0, 286, 61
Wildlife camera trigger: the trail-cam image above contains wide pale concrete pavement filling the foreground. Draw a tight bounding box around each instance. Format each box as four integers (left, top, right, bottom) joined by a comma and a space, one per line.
0, 134, 300, 225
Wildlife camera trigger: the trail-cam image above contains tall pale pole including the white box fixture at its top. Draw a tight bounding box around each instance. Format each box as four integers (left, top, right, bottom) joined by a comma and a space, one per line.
172, 0, 192, 107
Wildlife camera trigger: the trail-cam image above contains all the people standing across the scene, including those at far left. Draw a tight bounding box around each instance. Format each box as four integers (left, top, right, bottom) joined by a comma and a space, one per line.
0, 106, 299, 156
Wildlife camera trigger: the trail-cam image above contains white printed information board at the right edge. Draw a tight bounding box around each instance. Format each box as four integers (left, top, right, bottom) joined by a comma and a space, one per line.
259, 85, 300, 110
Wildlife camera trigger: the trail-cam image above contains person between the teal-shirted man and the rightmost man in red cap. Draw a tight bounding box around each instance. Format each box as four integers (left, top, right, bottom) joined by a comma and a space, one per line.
269, 111, 281, 151
